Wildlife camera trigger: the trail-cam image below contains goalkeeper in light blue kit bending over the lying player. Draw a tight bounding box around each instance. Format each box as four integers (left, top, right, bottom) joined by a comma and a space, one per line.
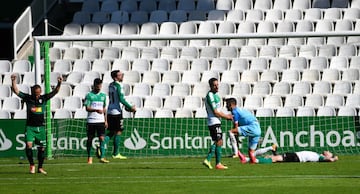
226, 98, 261, 164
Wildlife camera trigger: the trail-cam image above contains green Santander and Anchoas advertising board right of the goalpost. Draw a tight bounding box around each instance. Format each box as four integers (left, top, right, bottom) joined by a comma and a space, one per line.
53, 117, 360, 157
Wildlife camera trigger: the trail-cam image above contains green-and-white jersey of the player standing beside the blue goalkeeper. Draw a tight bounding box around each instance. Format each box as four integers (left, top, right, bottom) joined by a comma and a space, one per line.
205, 91, 221, 126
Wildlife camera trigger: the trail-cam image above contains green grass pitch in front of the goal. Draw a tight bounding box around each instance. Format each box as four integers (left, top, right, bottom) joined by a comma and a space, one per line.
0, 154, 360, 194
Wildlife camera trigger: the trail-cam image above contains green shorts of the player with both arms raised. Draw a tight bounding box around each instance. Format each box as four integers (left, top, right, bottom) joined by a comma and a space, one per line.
25, 126, 46, 147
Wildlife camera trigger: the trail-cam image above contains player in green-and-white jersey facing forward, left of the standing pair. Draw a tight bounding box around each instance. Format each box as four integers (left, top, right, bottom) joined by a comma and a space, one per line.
84, 78, 109, 164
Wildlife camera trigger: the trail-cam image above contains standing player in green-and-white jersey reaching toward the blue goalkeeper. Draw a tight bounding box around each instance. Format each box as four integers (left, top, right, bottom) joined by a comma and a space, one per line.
203, 78, 233, 169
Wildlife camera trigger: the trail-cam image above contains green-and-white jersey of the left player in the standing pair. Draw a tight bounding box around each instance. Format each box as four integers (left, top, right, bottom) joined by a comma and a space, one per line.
85, 91, 106, 123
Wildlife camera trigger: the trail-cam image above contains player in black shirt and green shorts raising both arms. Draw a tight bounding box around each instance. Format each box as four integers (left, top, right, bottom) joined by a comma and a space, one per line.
11, 74, 63, 175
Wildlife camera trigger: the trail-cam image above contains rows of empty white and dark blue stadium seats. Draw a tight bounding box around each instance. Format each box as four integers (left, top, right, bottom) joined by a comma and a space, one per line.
0, 0, 360, 118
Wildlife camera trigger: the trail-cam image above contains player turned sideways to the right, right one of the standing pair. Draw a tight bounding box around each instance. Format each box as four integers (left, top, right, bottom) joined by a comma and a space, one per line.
105, 70, 136, 159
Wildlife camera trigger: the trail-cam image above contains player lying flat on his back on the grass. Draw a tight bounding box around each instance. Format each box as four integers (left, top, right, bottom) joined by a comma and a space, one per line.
240, 151, 339, 164
